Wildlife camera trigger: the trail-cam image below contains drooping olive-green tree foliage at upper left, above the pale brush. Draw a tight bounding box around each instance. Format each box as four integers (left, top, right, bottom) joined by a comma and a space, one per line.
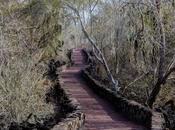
19, 0, 62, 59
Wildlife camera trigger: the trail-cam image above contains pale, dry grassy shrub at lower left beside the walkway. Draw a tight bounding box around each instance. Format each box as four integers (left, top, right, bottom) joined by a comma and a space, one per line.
0, 55, 53, 127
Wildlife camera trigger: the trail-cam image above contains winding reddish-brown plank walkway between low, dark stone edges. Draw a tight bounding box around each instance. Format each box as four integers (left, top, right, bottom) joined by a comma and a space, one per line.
61, 49, 144, 130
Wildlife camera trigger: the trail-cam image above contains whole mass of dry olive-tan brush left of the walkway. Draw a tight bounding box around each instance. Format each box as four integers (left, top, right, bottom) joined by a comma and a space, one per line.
0, 0, 60, 129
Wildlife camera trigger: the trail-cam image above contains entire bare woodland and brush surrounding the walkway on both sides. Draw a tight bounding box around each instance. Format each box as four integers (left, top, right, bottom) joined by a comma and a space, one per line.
0, 0, 175, 129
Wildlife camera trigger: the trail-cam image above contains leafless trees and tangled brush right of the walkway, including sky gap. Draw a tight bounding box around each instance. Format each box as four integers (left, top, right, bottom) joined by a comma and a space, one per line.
64, 0, 175, 129
